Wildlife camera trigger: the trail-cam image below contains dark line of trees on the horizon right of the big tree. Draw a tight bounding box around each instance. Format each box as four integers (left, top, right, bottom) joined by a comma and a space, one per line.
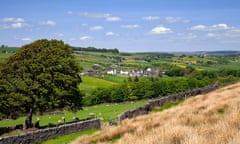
72, 47, 119, 53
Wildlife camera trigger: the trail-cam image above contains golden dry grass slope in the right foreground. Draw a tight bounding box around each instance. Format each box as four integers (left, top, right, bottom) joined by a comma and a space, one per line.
72, 83, 240, 144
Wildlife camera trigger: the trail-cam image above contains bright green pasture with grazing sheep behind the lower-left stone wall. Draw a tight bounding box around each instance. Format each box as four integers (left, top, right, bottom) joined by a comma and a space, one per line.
0, 101, 147, 127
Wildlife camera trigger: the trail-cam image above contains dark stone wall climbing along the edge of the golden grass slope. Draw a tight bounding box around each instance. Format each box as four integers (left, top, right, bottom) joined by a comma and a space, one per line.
118, 84, 219, 122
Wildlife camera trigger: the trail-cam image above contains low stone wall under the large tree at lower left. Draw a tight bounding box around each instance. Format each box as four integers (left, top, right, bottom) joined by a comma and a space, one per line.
0, 119, 101, 144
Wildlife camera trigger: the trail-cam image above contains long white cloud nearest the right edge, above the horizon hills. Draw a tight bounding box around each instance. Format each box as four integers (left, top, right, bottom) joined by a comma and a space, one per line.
190, 23, 233, 31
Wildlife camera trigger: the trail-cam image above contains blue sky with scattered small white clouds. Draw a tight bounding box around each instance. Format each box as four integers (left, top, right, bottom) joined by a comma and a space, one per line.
0, 0, 240, 52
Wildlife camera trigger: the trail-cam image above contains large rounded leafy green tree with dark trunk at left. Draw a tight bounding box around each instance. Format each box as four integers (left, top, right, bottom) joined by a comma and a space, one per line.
0, 39, 82, 128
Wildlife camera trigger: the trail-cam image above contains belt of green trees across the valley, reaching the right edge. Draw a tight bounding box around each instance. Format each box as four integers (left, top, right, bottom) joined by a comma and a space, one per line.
83, 69, 240, 105
